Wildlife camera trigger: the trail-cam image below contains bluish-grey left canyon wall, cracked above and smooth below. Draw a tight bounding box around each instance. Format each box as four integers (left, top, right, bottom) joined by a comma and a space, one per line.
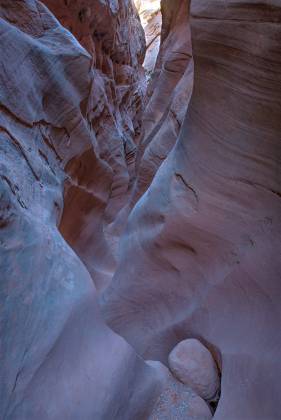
0, 0, 161, 420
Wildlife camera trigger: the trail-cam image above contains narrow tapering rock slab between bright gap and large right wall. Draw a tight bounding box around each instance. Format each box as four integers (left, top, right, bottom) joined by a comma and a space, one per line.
131, 0, 193, 206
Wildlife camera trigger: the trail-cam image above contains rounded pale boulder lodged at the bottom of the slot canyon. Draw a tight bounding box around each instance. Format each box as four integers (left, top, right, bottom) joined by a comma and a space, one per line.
169, 339, 219, 400
